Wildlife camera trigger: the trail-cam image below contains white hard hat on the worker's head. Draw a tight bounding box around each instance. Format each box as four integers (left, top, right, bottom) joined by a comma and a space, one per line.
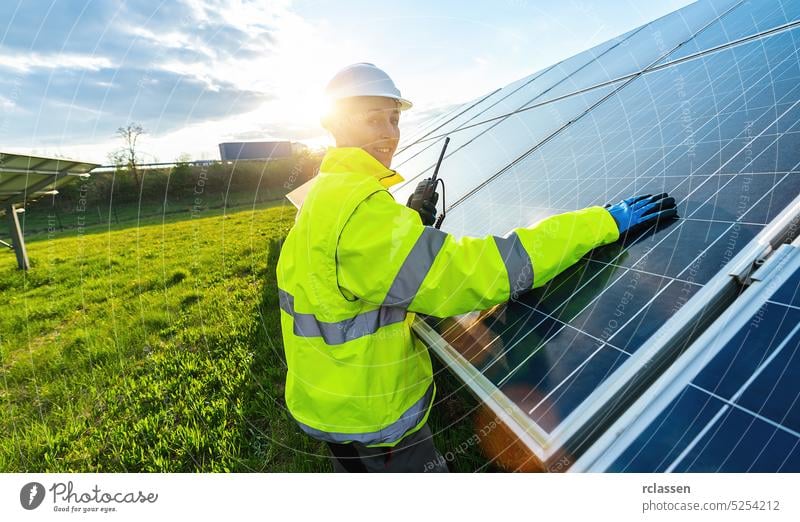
325, 62, 411, 111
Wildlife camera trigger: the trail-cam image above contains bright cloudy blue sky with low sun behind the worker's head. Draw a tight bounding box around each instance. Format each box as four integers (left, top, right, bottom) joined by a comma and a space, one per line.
0, 0, 690, 164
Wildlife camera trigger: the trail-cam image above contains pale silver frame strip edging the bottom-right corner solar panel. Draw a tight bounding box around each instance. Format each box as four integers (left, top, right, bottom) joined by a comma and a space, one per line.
569, 237, 800, 472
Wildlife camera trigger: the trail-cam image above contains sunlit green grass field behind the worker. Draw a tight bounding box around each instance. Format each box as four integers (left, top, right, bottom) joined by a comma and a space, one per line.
0, 197, 485, 472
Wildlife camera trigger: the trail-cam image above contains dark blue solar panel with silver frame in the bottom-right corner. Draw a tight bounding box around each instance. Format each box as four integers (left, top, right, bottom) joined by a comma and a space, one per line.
573, 237, 800, 472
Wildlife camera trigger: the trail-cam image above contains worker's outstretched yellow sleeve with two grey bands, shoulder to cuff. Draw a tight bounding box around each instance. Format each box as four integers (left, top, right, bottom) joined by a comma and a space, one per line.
337, 191, 619, 317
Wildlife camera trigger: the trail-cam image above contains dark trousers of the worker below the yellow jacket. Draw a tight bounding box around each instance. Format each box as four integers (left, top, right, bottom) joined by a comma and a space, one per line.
328, 423, 448, 473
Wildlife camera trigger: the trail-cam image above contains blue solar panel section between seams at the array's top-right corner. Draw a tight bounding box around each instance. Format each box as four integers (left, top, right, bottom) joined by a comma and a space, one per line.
663, 0, 800, 63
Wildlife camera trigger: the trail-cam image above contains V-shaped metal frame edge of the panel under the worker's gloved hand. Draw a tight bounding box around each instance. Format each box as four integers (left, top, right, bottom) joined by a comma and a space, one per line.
413, 189, 800, 471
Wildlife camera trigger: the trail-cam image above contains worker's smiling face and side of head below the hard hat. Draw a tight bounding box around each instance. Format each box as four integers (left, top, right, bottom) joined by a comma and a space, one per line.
324, 96, 400, 168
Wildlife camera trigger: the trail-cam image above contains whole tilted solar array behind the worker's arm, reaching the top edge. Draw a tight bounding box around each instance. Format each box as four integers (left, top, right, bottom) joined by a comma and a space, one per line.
393, 0, 800, 467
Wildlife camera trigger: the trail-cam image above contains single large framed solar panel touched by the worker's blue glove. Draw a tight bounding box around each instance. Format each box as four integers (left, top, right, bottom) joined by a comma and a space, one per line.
404, 3, 800, 468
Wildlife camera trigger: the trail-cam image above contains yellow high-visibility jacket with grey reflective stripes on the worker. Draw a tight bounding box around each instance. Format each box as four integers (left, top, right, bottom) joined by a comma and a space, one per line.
277, 147, 619, 446
